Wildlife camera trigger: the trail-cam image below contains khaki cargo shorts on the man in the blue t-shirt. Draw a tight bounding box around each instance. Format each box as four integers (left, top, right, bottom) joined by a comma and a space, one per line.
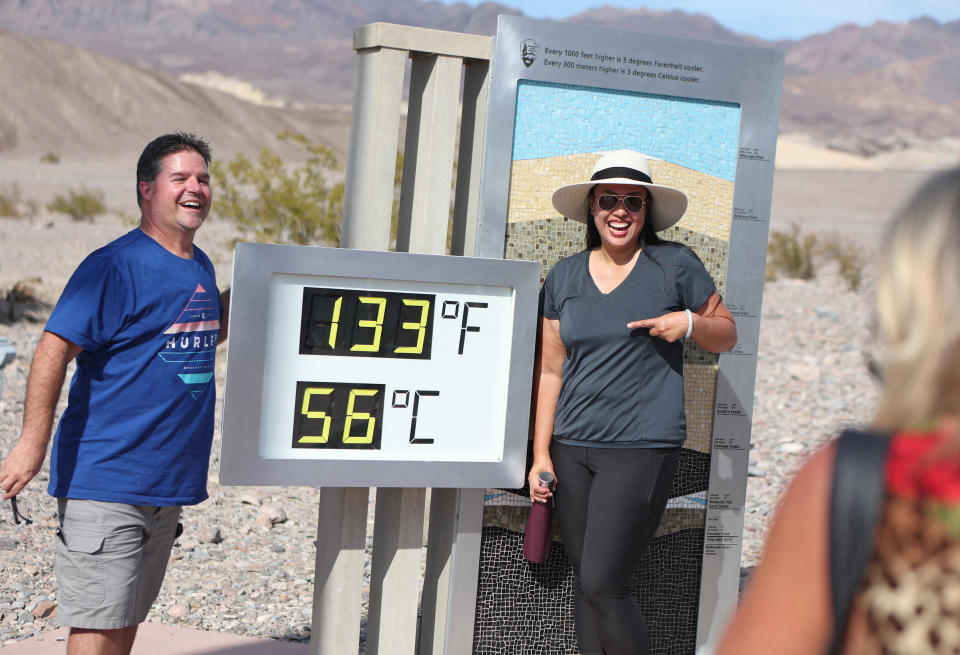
56, 498, 180, 630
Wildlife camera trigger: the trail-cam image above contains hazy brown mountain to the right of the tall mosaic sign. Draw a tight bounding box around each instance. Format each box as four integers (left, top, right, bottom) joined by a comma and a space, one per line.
780, 18, 960, 154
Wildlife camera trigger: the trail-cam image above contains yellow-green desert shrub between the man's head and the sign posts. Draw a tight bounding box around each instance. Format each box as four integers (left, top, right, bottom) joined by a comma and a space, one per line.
210, 132, 343, 245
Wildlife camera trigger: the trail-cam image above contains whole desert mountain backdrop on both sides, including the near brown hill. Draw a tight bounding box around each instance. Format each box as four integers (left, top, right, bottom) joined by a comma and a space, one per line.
0, 0, 960, 160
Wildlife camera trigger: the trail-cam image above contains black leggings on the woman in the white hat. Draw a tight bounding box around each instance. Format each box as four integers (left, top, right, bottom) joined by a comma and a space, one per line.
550, 441, 680, 655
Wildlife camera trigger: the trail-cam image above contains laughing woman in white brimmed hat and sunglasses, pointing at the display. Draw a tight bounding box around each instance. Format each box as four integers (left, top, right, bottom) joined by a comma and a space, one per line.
529, 150, 737, 655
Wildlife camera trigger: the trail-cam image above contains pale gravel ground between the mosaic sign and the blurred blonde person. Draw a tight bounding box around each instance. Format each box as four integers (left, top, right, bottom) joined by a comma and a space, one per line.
741, 271, 880, 570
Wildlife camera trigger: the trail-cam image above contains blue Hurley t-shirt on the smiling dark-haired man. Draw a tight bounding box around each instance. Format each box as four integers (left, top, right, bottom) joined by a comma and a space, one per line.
46, 228, 220, 506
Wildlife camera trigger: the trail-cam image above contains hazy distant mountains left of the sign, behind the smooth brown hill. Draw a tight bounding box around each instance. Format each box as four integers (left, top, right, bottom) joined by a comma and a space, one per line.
0, 0, 517, 105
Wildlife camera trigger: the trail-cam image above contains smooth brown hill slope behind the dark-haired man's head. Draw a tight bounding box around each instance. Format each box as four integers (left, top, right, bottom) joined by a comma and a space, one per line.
0, 31, 348, 160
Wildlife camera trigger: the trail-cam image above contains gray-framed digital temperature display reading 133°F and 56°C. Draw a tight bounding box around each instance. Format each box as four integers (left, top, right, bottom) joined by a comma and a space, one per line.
221, 244, 539, 487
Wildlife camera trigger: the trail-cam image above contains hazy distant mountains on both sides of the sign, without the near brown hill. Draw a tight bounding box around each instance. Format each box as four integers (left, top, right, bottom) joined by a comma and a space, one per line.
0, 0, 960, 155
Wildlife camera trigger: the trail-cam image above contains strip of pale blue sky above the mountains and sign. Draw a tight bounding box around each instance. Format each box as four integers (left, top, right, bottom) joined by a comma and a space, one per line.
454, 0, 960, 40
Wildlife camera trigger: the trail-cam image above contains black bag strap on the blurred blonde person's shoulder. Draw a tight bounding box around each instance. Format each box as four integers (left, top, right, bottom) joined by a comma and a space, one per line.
828, 430, 890, 655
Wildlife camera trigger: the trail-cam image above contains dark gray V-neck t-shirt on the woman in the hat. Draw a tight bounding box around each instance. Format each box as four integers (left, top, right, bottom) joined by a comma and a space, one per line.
540, 243, 716, 448
